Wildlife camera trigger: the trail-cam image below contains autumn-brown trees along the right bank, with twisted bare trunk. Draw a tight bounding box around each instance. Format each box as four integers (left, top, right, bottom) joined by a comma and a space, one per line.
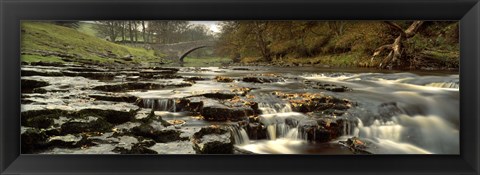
217, 21, 459, 68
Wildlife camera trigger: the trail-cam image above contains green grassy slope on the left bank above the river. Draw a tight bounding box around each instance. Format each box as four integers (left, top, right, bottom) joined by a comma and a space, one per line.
21, 22, 160, 63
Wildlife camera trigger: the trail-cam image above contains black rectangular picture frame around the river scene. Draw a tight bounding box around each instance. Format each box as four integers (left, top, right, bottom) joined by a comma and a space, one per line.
0, 0, 480, 174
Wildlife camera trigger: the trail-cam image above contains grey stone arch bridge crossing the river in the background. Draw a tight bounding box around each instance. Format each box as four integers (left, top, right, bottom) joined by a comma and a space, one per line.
151, 40, 215, 63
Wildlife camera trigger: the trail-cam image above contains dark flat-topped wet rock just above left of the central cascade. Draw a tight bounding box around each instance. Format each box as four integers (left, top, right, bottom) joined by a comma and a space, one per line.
201, 106, 254, 121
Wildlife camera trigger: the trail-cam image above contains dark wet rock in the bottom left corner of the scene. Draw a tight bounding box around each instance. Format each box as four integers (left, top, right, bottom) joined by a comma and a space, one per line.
20, 129, 48, 154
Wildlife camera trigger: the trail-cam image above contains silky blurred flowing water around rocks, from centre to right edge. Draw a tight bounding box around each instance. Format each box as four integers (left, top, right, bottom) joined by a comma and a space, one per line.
132, 67, 460, 154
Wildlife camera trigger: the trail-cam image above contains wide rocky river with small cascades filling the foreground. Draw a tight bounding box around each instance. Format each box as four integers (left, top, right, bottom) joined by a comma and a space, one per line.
22, 66, 460, 154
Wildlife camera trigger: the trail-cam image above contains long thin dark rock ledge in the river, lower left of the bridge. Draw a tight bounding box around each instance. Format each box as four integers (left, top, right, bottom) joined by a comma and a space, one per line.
93, 82, 192, 92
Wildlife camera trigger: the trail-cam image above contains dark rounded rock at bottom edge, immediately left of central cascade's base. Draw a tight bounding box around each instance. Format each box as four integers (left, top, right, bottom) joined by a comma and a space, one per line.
192, 126, 233, 154
